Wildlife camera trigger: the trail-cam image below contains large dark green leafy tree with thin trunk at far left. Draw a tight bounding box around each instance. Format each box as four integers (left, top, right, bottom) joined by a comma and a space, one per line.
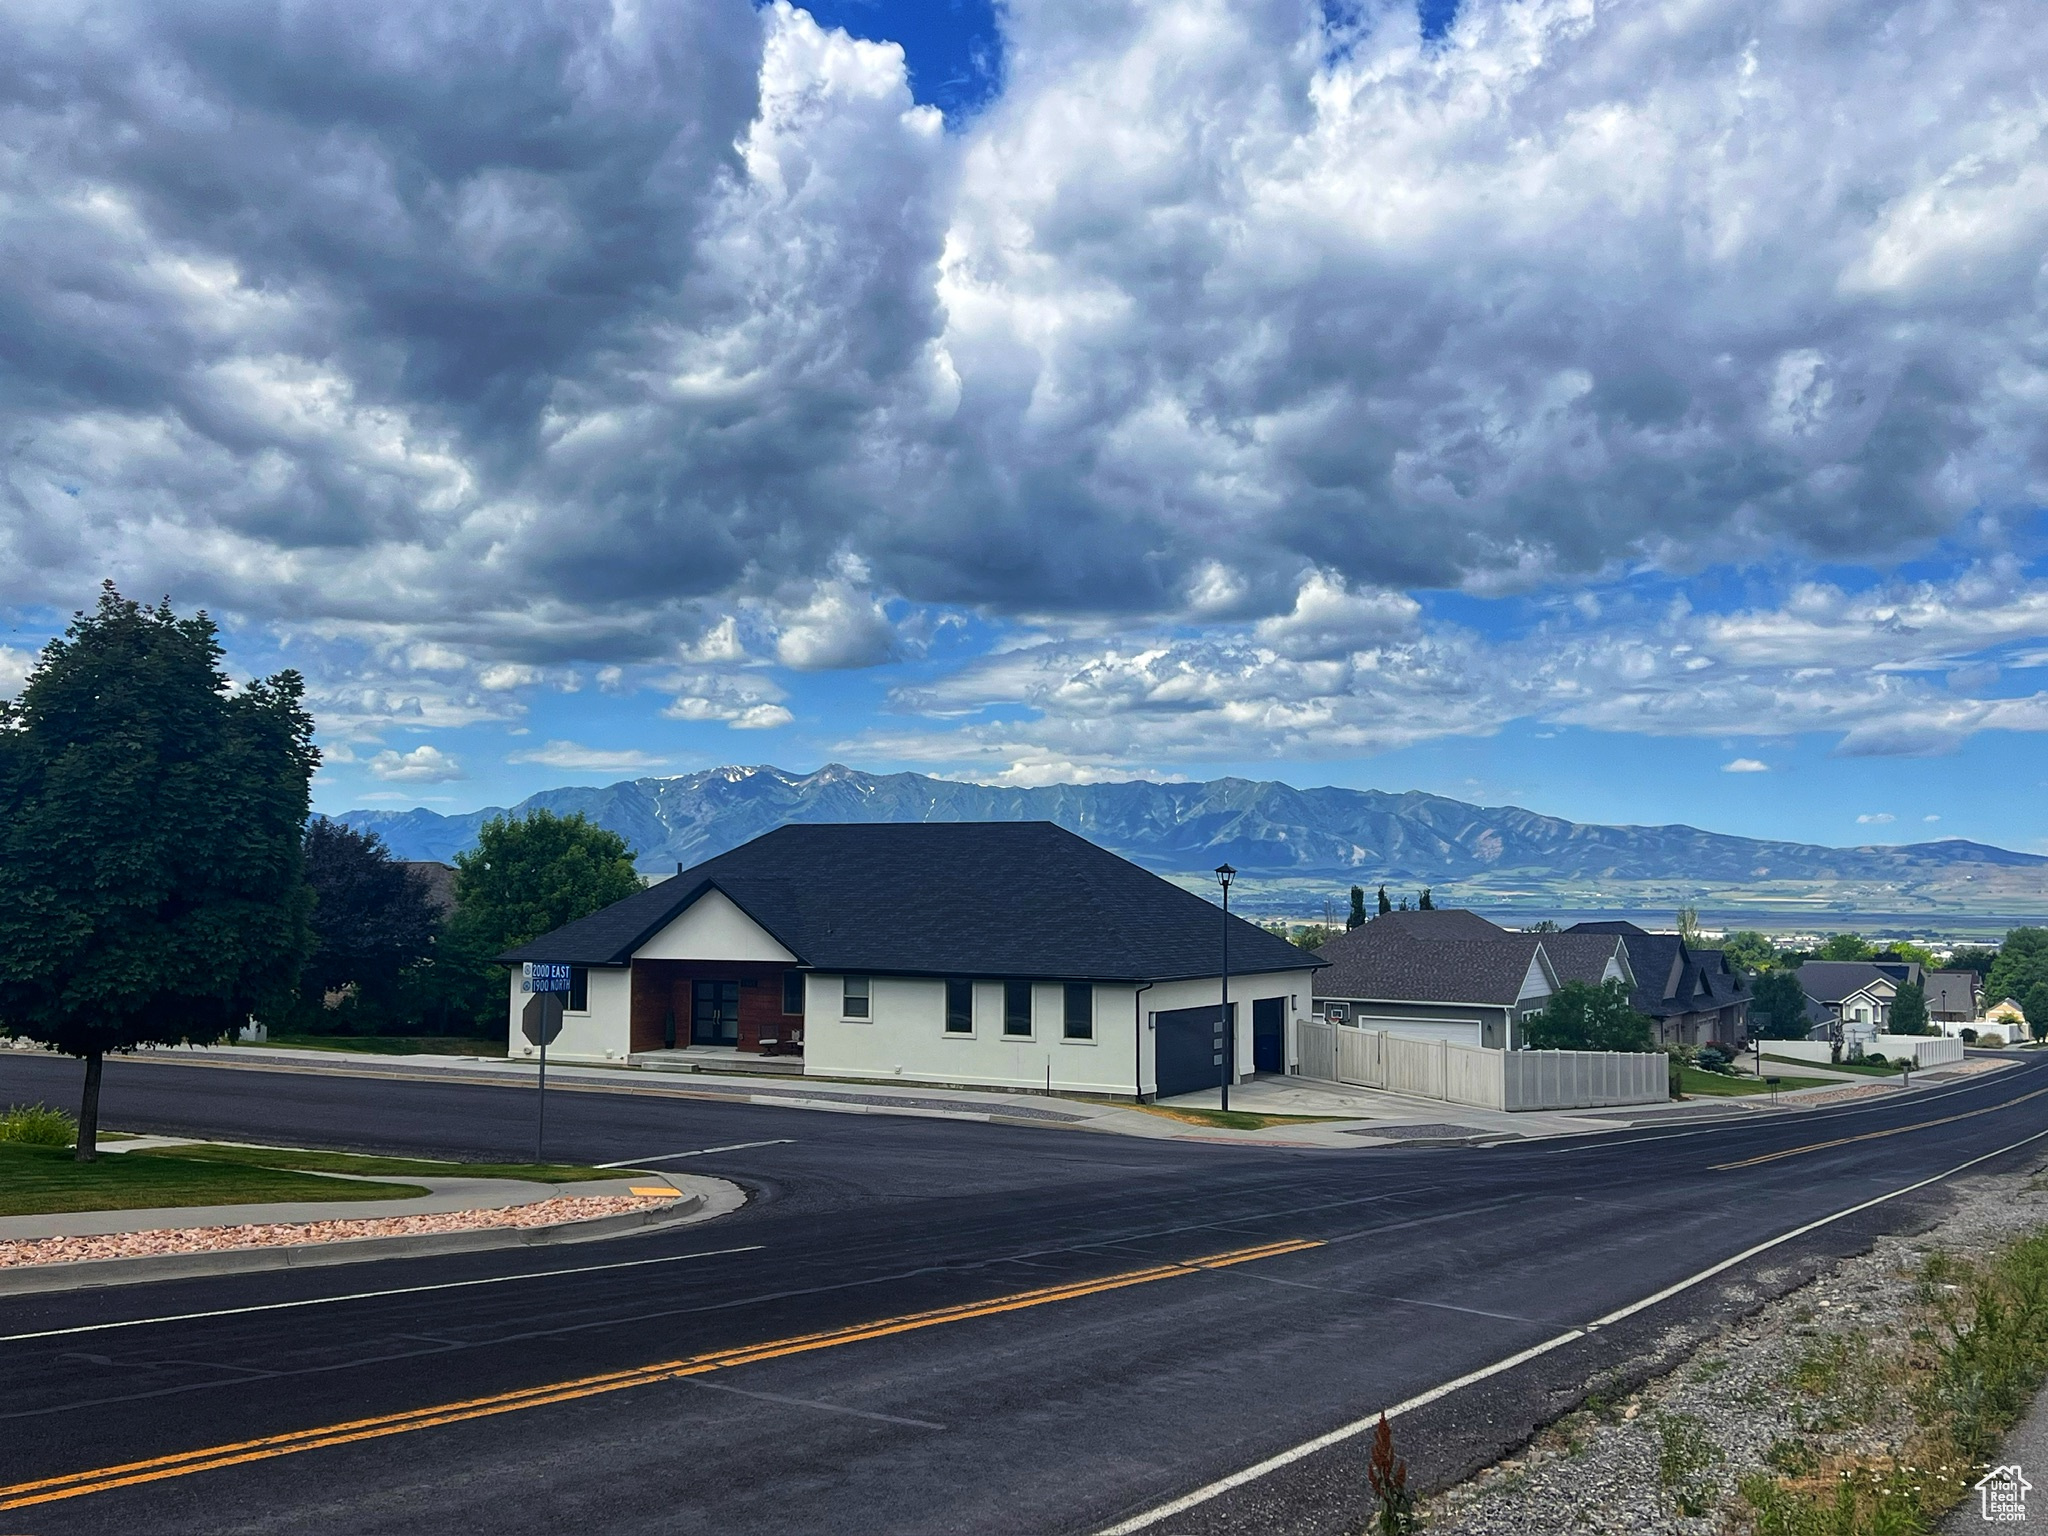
0, 582, 319, 1161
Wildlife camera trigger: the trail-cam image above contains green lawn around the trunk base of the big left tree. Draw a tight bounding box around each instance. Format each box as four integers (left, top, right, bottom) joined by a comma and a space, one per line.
0, 1143, 426, 1217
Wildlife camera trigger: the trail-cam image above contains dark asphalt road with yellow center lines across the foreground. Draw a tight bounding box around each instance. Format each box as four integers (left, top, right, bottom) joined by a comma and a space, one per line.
0, 1053, 2048, 1536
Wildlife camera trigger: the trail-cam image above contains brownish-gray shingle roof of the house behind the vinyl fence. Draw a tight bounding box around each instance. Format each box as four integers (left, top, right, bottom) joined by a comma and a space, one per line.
1315, 911, 1538, 1008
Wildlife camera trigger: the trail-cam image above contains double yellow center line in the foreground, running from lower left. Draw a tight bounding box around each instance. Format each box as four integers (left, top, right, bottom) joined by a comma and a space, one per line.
0, 1239, 1321, 1509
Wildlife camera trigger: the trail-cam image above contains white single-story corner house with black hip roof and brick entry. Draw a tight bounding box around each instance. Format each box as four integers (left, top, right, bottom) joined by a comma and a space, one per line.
498, 821, 1321, 1098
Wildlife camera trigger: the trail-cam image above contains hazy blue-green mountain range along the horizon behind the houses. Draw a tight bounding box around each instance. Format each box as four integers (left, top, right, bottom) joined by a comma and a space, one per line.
336, 764, 2048, 918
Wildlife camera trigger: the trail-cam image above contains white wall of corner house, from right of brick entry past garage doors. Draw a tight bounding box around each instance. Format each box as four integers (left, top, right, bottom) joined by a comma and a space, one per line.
798, 971, 1309, 1098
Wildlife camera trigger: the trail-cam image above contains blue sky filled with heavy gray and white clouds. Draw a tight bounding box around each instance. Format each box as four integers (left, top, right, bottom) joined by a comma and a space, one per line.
0, 0, 2048, 848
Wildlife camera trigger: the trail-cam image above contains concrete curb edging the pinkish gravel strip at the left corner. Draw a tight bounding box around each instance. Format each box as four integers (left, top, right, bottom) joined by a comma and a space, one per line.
0, 1180, 737, 1296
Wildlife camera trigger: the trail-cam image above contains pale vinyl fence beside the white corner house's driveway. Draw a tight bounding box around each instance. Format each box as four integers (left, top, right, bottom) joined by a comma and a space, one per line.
1296, 1020, 1671, 1110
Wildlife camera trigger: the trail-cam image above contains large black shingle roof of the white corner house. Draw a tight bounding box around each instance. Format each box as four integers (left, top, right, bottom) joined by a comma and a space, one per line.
498, 821, 1317, 981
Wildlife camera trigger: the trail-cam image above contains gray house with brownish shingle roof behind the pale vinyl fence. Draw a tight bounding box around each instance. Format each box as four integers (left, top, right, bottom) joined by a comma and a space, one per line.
1315, 909, 1628, 1051
